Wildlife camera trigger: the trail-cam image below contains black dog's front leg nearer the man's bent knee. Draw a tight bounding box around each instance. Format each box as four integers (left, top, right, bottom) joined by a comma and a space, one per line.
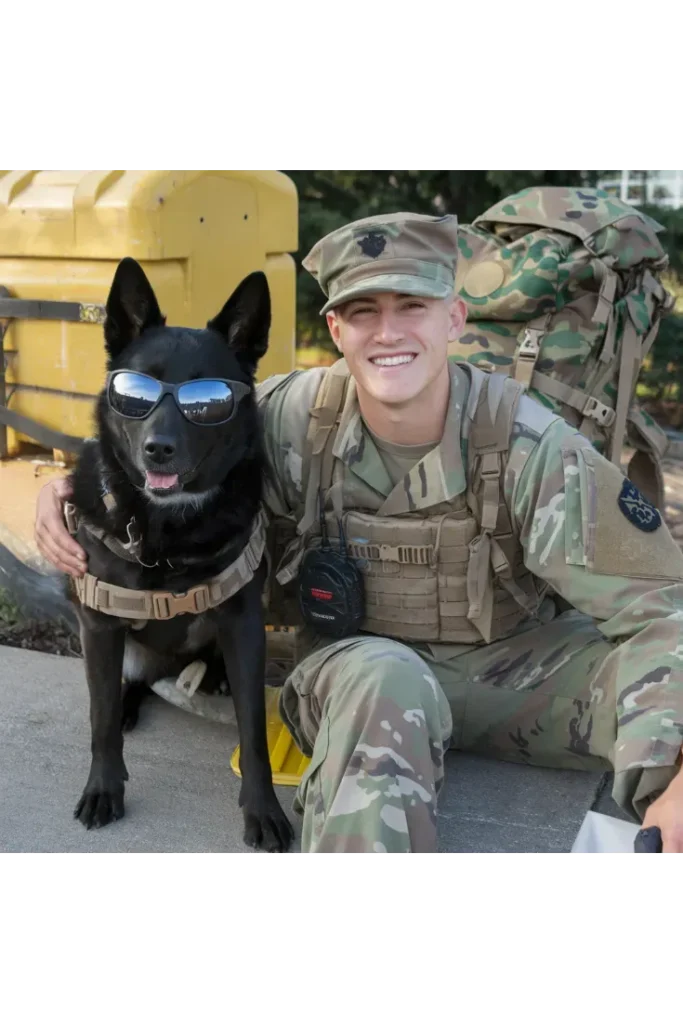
218, 580, 294, 853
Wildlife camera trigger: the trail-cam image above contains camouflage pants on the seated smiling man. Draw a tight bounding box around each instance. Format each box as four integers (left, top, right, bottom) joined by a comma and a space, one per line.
280, 611, 675, 856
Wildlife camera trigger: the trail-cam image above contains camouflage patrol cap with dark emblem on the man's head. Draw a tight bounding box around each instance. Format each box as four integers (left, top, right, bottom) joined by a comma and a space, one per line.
303, 213, 458, 315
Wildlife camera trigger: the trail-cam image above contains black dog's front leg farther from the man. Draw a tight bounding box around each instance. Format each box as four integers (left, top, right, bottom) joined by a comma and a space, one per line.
74, 612, 128, 828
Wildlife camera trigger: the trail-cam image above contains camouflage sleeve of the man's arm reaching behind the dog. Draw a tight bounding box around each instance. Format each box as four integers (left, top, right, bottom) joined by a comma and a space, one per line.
256, 368, 325, 517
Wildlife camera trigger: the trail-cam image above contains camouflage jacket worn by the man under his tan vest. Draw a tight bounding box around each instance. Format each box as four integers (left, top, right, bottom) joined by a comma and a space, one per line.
258, 364, 683, 753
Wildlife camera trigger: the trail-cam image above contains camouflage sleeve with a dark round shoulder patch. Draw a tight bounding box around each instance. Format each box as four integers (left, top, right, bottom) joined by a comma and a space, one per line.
507, 409, 683, 622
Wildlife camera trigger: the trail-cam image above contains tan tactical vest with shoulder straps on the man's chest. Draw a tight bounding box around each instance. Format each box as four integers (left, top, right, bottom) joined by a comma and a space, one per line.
275, 359, 547, 644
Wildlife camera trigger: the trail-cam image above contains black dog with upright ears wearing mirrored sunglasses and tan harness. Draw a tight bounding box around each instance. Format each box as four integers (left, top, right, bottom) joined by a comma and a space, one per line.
68, 259, 293, 853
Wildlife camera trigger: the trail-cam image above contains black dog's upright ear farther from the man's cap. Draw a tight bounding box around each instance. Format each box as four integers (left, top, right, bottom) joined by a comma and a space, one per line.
104, 257, 166, 358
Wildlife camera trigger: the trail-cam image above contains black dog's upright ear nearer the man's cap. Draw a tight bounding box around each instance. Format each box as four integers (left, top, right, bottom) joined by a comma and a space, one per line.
207, 270, 271, 373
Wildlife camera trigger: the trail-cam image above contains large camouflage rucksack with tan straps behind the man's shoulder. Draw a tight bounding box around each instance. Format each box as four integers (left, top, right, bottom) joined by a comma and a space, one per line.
450, 186, 675, 509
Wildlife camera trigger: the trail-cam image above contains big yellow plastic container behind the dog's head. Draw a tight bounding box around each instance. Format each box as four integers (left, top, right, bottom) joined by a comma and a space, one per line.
0, 167, 298, 456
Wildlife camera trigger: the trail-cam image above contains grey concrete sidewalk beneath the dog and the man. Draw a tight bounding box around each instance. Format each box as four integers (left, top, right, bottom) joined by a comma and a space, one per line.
0, 646, 617, 856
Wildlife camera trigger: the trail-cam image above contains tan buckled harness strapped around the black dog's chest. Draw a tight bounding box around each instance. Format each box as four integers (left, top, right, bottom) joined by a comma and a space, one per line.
65, 493, 267, 622
